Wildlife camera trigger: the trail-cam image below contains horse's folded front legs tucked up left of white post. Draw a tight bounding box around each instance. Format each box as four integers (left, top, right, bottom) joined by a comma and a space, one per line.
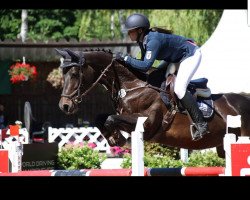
102, 114, 142, 146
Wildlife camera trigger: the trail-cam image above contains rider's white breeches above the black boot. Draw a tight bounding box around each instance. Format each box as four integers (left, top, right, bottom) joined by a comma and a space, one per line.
174, 49, 202, 99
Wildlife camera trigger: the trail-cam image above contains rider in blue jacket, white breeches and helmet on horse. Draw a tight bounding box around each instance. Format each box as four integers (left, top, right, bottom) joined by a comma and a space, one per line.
116, 13, 209, 140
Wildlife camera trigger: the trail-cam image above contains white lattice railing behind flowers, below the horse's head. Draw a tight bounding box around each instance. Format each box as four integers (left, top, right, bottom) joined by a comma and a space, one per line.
48, 127, 110, 153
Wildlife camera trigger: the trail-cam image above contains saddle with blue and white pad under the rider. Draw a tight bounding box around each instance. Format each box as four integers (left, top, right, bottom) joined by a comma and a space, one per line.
161, 74, 214, 130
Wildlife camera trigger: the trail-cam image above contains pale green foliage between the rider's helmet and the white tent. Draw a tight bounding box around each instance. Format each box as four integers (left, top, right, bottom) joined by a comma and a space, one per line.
149, 10, 222, 45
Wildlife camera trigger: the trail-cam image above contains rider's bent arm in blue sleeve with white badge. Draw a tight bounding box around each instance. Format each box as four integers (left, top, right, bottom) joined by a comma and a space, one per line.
124, 39, 161, 72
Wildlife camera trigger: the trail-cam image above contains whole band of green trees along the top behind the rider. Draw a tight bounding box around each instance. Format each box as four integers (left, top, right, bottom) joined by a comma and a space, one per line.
0, 9, 222, 45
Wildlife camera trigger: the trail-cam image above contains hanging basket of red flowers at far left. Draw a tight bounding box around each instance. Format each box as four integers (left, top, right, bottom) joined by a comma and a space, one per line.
9, 62, 37, 84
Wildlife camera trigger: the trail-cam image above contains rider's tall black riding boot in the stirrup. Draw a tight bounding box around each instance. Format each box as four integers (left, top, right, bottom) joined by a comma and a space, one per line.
180, 91, 209, 140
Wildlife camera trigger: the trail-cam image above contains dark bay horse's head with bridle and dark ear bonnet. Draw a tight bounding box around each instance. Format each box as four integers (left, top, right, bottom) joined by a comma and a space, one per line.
56, 49, 112, 114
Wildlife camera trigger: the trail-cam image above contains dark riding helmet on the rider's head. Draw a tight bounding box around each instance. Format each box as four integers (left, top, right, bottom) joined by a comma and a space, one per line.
125, 14, 150, 31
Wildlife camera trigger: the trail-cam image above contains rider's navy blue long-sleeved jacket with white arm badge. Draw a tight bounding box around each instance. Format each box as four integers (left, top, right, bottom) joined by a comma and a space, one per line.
125, 31, 198, 71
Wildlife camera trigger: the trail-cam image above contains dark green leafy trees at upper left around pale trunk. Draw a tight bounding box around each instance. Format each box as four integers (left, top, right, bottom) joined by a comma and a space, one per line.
0, 9, 81, 41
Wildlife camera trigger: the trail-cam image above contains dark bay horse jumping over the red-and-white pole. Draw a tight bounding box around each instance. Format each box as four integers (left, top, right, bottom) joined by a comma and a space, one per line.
57, 49, 250, 157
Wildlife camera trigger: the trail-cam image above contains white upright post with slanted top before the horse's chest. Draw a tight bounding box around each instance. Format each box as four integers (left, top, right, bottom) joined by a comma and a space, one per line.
131, 117, 147, 176
